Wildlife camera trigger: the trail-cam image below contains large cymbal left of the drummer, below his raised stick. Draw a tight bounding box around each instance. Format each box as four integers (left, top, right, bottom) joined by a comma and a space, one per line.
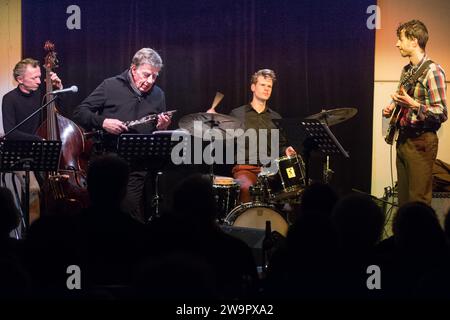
178, 112, 244, 140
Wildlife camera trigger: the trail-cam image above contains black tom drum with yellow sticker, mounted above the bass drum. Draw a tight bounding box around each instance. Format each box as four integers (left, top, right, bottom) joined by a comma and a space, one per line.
258, 155, 305, 200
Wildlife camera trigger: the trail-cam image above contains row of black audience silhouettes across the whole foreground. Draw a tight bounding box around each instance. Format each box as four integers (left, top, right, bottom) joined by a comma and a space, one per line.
0, 159, 450, 302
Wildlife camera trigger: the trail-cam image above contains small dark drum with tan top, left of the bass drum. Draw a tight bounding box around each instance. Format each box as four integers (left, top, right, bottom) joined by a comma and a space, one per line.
213, 176, 240, 221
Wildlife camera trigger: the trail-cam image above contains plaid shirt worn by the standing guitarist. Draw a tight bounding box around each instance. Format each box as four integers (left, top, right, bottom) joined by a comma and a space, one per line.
400, 56, 447, 130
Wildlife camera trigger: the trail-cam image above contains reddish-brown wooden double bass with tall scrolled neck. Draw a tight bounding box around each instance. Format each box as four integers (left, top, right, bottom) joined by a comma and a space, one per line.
37, 41, 91, 213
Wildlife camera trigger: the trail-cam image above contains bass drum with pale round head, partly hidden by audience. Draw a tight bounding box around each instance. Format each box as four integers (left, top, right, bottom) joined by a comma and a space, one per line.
225, 202, 289, 237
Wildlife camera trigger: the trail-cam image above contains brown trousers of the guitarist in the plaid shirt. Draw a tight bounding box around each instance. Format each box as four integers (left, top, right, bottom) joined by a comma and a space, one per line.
396, 132, 438, 206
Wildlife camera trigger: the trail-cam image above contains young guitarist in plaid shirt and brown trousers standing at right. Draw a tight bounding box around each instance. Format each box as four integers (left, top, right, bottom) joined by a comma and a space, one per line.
383, 20, 447, 205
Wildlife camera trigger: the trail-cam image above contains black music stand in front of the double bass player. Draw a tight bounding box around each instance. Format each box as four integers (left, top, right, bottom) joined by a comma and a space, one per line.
0, 140, 62, 231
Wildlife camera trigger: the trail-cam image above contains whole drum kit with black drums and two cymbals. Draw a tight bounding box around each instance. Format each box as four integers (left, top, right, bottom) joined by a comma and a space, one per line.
179, 108, 357, 236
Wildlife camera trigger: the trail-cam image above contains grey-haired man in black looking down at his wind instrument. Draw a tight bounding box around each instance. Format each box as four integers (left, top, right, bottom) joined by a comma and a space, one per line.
74, 48, 171, 222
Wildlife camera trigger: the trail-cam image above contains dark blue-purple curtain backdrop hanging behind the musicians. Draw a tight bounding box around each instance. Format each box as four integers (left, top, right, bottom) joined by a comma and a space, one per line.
22, 0, 376, 192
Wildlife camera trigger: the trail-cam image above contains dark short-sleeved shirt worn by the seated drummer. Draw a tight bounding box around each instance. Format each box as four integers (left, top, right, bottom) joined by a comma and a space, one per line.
230, 104, 287, 165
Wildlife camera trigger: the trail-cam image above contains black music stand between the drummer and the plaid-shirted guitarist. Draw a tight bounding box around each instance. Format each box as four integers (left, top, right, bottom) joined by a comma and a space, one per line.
300, 119, 350, 186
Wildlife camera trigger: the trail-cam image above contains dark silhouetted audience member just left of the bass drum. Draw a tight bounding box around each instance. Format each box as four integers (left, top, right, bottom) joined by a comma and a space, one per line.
142, 174, 258, 299
